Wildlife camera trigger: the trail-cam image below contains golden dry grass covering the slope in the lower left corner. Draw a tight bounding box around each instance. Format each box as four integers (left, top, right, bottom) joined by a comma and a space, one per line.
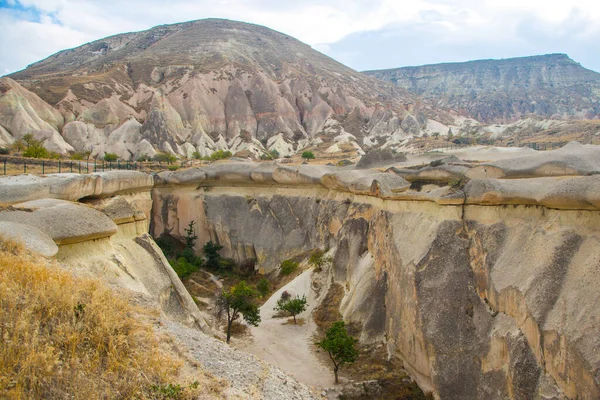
0, 237, 223, 399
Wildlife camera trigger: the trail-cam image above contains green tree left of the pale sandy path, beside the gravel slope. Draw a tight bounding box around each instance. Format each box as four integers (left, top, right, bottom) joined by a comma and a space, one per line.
216, 281, 260, 343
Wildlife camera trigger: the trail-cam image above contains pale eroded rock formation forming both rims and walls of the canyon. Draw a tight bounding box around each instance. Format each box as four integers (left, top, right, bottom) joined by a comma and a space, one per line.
0, 144, 600, 399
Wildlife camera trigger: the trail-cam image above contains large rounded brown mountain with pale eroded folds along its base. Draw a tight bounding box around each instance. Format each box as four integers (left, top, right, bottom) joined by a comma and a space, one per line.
0, 19, 454, 159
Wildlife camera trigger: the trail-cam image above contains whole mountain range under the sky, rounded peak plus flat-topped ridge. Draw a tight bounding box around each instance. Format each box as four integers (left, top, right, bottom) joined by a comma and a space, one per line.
0, 19, 600, 159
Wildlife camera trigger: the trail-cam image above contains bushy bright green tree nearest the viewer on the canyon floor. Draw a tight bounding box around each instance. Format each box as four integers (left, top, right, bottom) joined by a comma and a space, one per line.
317, 321, 358, 383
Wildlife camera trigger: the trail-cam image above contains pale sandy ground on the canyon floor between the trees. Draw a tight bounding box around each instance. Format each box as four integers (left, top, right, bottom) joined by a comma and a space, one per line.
236, 269, 333, 388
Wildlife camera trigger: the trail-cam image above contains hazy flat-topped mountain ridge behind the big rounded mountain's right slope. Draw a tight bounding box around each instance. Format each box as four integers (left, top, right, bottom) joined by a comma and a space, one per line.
365, 54, 600, 123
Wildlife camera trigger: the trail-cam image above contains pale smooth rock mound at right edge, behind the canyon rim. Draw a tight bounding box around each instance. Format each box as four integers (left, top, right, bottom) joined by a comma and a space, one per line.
467, 142, 600, 179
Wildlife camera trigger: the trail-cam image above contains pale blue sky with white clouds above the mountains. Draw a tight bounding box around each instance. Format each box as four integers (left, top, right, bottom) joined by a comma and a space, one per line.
0, 0, 600, 75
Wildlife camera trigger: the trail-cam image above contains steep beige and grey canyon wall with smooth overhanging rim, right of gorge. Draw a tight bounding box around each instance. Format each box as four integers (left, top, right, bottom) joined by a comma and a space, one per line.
151, 163, 600, 399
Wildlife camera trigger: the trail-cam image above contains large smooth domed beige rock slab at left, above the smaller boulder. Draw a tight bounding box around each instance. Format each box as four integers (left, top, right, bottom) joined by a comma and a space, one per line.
0, 201, 117, 245
